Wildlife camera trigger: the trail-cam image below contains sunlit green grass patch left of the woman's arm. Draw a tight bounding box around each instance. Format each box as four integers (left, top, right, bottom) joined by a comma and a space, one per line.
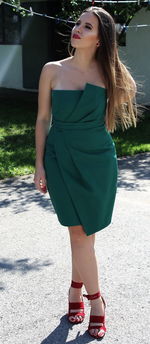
0, 97, 37, 179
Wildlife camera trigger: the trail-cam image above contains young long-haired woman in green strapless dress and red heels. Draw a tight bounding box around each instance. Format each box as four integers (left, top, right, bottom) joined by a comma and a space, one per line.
34, 7, 136, 338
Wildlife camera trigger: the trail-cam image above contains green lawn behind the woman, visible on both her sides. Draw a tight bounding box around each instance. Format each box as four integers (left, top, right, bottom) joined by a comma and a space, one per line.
0, 95, 150, 179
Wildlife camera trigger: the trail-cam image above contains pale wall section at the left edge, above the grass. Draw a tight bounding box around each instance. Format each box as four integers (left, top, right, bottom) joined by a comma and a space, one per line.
0, 45, 23, 89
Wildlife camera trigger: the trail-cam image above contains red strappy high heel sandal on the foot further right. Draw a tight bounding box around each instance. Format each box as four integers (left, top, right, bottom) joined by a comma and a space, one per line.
83, 292, 106, 339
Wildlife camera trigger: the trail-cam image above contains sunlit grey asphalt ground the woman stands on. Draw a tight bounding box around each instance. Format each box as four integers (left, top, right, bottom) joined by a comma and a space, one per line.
0, 153, 150, 344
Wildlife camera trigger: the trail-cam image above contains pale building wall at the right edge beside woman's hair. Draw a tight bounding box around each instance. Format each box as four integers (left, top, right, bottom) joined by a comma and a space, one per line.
119, 8, 150, 105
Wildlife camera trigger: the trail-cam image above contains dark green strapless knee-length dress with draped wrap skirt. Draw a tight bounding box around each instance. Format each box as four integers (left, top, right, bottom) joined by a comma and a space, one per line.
44, 83, 118, 235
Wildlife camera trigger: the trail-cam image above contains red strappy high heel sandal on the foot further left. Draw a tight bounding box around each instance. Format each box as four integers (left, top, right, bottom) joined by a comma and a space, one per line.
68, 281, 85, 324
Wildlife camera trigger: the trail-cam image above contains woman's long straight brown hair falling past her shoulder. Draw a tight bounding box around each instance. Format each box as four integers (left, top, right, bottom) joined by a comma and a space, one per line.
68, 6, 142, 132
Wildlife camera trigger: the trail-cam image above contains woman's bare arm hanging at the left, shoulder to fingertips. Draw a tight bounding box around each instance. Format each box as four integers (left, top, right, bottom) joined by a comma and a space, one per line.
34, 63, 54, 193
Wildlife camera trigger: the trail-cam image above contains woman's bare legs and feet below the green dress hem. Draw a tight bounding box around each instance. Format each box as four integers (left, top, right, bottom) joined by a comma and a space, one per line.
68, 226, 104, 335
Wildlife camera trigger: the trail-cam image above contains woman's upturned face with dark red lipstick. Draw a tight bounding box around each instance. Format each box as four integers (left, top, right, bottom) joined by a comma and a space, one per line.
71, 12, 99, 48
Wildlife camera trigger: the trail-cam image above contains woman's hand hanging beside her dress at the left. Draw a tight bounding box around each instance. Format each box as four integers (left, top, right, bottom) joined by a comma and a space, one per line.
34, 166, 47, 193
